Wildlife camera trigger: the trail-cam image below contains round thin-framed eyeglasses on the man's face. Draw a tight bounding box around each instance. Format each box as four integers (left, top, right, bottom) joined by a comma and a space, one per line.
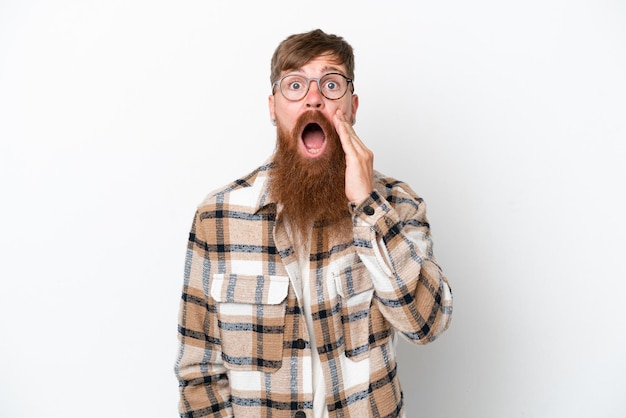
272, 73, 354, 102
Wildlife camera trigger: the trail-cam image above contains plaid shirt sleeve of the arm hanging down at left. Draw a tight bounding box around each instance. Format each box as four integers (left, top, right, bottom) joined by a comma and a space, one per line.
175, 213, 232, 418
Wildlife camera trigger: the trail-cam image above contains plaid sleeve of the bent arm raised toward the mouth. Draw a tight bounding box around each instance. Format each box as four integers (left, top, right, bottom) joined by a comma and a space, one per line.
352, 182, 452, 344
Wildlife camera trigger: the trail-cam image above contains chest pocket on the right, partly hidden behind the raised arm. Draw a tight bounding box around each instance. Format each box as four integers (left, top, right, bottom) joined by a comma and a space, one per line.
335, 263, 374, 361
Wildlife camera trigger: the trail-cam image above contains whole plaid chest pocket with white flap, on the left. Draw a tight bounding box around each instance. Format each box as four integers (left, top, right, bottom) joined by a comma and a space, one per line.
211, 274, 289, 372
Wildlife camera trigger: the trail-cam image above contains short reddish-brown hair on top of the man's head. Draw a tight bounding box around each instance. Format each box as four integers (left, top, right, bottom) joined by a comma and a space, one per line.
270, 29, 354, 83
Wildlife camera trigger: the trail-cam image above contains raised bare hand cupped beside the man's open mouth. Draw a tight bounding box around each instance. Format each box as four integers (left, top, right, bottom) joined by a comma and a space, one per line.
333, 109, 374, 203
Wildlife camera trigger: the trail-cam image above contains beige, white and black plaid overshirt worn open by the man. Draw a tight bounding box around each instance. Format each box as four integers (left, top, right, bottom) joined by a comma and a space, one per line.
175, 158, 452, 418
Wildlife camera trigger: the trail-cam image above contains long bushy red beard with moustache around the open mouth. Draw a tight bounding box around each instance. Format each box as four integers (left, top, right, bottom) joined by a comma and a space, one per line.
269, 111, 352, 245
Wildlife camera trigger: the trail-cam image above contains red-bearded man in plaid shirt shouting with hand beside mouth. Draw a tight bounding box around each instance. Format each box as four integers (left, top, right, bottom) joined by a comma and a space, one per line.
176, 30, 452, 418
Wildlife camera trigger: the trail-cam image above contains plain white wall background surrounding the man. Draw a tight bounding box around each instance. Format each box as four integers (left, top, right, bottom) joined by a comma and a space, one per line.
0, 0, 626, 418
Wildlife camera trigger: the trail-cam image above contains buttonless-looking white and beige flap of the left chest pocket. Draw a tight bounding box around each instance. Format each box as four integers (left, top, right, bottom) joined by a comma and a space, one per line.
211, 274, 289, 305
